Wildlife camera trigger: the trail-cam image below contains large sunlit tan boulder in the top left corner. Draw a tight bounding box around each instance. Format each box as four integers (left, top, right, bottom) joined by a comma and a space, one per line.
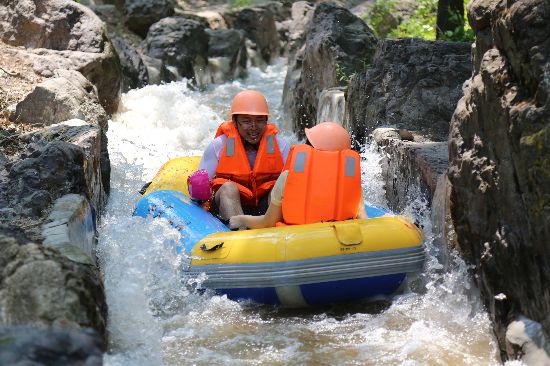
0, 0, 120, 113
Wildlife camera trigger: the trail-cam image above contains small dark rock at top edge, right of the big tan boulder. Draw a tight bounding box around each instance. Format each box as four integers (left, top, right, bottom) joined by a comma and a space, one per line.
124, 0, 174, 38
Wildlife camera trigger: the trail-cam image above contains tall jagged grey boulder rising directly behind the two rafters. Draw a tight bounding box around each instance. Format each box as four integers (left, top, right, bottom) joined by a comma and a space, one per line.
283, 3, 377, 135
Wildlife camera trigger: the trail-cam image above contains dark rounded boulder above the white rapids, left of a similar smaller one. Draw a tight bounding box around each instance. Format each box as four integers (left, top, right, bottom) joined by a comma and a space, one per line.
143, 17, 209, 85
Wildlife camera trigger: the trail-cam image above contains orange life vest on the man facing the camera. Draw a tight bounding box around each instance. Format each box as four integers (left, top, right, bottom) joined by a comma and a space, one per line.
212, 121, 283, 206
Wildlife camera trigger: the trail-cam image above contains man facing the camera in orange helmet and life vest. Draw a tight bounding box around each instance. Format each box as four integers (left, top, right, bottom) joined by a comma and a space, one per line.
199, 90, 290, 220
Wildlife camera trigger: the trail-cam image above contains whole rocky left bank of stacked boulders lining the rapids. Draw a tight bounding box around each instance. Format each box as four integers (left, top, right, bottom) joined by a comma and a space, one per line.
0, 0, 121, 358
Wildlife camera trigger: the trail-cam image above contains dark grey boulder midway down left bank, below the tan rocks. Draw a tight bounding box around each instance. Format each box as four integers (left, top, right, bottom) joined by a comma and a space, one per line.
0, 120, 110, 239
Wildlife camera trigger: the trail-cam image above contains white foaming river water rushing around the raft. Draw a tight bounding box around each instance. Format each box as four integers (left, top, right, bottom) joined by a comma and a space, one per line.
98, 60, 498, 366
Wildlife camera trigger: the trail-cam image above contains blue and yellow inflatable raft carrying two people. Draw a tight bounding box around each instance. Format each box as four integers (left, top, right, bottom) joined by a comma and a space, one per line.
134, 157, 424, 307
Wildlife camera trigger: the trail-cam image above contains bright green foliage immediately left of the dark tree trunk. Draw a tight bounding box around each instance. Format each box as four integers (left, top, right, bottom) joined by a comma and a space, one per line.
389, 0, 438, 40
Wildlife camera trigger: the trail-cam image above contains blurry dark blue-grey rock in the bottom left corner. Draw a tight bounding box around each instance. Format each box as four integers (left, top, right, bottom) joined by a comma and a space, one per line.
0, 326, 103, 366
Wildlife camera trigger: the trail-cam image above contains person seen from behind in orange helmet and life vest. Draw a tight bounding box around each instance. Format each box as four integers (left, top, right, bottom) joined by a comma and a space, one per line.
229, 122, 367, 229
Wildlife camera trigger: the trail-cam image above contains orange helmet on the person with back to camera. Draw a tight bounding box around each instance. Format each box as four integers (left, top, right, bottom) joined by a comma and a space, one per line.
306, 122, 351, 151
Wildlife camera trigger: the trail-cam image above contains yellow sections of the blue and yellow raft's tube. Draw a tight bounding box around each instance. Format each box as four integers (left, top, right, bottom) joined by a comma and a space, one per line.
145, 156, 424, 266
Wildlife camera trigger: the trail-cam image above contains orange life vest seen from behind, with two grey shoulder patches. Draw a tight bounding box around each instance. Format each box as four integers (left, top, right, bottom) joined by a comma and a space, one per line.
282, 145, 361, 225
